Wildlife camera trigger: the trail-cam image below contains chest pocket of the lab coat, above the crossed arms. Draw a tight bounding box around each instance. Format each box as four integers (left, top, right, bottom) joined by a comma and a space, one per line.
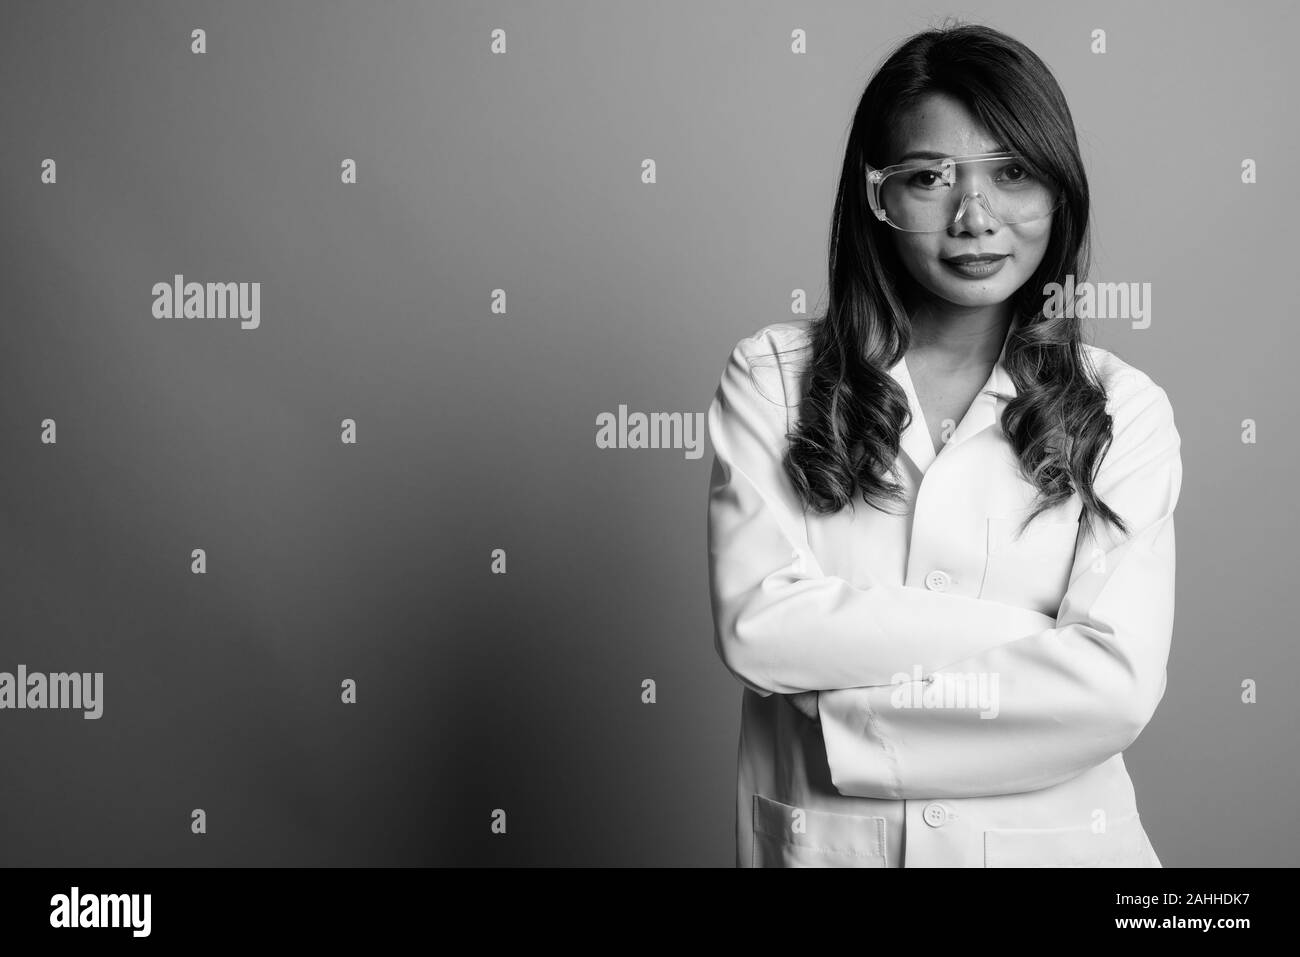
979, 514, 1079, 618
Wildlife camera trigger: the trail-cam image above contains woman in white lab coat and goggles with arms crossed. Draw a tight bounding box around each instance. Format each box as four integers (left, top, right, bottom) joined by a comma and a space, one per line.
709, 20, 1182, 867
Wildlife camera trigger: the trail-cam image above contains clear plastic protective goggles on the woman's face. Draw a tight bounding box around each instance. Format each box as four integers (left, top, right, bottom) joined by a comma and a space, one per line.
867, 152, 1063, 233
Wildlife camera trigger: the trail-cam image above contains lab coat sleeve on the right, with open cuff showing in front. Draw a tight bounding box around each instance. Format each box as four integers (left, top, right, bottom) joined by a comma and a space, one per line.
818, 377, 1183, 800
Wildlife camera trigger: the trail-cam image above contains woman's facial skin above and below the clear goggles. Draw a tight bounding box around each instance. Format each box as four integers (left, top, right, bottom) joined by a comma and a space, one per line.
889, 94, 1052, 307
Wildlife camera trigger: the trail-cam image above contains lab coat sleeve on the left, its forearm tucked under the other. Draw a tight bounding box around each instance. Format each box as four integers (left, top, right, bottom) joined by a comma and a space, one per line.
707, 333, 1052, 696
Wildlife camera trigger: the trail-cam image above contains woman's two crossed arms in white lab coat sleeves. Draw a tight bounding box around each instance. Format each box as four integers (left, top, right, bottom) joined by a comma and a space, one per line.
709, 339, 1182, 798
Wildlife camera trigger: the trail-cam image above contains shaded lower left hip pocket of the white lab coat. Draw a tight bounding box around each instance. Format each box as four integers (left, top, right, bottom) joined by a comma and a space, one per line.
751, 794, 885, 867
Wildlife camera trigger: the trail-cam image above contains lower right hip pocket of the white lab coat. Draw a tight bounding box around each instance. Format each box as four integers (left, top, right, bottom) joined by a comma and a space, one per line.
984, 814, 1161, 867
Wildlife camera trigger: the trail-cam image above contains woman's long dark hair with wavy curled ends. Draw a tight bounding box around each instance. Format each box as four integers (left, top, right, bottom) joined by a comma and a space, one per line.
783, 23, 1128, 534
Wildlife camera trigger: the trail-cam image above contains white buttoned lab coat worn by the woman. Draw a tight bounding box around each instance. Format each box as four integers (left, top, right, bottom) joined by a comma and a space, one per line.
709, 320, 1182, 867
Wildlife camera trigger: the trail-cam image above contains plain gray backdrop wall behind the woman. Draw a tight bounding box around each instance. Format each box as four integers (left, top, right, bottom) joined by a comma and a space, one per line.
0, 0, 1300, 866
